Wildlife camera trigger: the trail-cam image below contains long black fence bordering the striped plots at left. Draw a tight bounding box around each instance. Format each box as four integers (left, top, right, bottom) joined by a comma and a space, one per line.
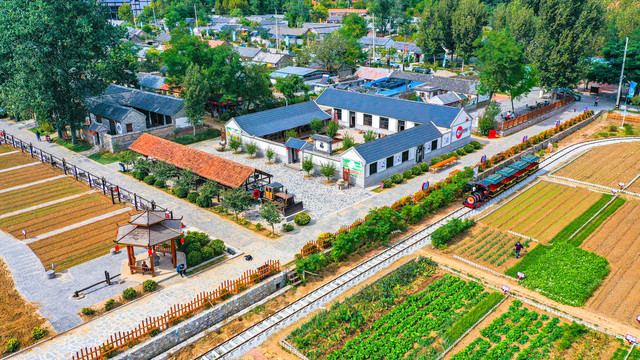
0, 130, 167, 211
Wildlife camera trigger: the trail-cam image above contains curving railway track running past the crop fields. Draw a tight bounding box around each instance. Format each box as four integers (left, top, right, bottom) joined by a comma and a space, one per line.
198, 137, 640, 360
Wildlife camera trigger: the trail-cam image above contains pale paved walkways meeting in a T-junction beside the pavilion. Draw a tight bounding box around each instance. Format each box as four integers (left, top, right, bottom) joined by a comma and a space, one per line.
0, 91, 612, 359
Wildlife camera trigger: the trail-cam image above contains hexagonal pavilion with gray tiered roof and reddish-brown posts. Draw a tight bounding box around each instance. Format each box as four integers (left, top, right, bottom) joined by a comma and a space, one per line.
116, 211, 184, 276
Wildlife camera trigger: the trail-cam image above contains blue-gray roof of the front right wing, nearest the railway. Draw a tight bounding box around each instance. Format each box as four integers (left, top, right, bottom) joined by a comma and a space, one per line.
355, 123, 442, 163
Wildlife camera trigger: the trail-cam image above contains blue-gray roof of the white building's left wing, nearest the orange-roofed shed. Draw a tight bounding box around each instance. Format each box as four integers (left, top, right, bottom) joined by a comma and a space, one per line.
234, 101, 331, 136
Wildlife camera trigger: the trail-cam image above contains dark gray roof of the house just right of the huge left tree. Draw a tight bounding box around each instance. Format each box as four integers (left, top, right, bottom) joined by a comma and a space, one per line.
97, 84, 184, 116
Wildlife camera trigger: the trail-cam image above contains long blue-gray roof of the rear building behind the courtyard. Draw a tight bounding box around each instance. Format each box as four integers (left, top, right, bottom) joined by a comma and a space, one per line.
316, 89, 462, 128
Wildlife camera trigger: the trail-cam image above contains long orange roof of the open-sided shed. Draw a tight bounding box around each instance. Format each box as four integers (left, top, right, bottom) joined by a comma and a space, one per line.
129, 133, 256, 187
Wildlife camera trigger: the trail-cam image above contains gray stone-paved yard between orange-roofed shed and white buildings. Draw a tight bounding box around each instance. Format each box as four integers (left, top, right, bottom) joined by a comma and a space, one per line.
190, 139, 371, 220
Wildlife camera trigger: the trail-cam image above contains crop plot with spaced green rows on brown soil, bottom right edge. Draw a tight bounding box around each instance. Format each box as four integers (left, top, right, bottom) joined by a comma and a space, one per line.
449, 300, 616, 360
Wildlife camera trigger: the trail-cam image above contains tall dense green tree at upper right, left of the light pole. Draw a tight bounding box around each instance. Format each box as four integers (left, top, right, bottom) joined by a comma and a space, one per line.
534, 0, 604, 89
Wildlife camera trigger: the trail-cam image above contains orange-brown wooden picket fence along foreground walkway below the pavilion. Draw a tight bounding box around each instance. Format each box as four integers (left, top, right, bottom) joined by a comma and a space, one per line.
72, 260, 280, 360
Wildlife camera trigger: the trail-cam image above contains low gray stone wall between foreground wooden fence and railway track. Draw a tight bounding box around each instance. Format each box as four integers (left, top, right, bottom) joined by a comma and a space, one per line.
114, 272, 286, 360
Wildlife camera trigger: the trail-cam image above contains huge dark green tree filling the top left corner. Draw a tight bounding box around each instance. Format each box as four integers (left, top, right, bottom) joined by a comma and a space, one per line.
0, 0, 136, 143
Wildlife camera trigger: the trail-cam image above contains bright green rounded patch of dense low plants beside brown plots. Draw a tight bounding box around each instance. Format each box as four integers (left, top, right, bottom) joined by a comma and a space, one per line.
506, 243, 609, 306
